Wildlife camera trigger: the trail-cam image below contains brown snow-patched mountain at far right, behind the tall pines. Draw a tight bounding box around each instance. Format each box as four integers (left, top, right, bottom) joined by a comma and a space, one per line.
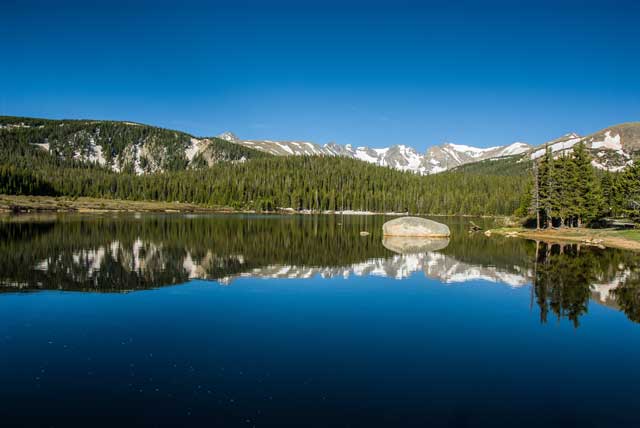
530, 122, 640, 171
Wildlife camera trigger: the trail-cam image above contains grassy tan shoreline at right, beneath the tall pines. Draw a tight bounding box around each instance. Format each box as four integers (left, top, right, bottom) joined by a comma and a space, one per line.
485, 227, 640, 251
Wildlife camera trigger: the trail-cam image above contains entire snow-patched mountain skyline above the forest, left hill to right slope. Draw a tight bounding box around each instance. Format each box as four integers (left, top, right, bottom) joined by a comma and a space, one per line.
0, 116, 640, 175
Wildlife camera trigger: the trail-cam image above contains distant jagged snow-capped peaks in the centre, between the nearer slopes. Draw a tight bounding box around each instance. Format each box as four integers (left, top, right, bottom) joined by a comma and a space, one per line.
218, 132, 531, 175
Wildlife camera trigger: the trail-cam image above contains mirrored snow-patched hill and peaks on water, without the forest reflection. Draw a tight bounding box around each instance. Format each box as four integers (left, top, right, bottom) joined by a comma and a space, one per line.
3, 239, 531, 291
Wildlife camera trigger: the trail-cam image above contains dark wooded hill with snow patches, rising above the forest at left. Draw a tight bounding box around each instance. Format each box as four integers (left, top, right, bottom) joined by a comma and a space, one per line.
0, 116, 269, 174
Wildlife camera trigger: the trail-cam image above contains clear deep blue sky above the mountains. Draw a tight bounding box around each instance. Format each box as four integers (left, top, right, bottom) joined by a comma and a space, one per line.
0, 0, 640, 150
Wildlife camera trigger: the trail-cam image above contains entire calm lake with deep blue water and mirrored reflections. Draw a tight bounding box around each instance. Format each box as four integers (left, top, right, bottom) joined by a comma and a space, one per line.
0, 214, 640, 427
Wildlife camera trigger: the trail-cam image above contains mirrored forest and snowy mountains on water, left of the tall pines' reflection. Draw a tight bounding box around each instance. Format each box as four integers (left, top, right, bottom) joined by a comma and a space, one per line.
0, 216, 526, 291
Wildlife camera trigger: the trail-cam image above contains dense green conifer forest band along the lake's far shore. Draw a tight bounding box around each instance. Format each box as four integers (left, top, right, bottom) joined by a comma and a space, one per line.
0, 138, 527, 215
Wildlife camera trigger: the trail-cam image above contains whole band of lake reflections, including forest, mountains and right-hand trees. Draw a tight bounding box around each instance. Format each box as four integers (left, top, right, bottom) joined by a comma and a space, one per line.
0, 216, 640, 327
